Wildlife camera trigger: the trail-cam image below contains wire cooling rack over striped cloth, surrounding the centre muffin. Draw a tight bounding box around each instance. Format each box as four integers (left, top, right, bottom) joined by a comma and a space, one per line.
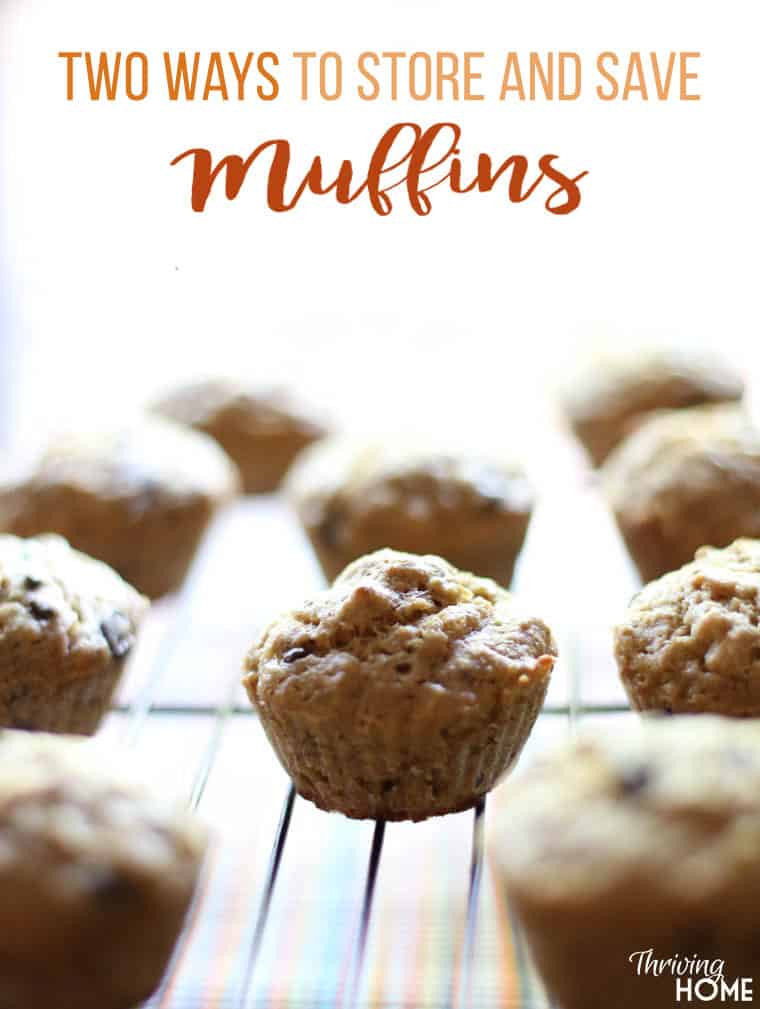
103, 472, 635, 1009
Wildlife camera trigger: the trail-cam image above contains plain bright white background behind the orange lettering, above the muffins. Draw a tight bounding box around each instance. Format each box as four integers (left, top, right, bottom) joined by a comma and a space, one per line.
0, 0, 759, 445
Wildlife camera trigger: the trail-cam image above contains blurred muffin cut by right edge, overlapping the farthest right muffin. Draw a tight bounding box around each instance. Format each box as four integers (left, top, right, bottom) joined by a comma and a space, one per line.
603, 397, 760, 582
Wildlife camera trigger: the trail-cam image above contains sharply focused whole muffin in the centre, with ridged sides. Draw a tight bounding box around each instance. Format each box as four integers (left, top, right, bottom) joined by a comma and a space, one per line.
243, 550, 556, 820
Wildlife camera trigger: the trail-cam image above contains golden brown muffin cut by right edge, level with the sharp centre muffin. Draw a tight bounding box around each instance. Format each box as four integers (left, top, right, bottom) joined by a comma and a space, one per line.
615, 540, 760, 717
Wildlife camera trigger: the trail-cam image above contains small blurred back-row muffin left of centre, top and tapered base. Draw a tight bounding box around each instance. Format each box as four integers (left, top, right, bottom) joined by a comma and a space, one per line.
152, 379, 326, 494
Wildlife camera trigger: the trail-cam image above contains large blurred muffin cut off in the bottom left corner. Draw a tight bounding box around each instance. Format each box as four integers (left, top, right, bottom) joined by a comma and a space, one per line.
0, 732, 205, 1009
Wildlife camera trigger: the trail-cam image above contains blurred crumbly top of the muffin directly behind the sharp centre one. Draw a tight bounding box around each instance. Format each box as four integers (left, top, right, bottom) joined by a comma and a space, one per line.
288, 437, 534, 533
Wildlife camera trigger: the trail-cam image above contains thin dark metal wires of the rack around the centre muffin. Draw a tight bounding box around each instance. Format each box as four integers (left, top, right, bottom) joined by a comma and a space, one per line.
112, 504, 626, 1009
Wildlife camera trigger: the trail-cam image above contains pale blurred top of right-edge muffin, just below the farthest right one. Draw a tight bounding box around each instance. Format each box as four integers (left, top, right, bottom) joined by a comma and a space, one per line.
603, 404, 760, 516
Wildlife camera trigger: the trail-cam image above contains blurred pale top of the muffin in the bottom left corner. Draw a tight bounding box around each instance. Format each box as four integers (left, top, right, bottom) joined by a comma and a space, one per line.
0, 731, 205, 904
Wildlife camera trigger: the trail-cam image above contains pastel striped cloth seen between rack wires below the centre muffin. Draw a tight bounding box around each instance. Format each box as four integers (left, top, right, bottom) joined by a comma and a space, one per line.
133, 715, 546, 1009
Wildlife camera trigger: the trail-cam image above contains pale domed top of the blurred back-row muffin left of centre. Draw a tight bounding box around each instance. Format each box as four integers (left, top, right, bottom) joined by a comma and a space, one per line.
151, 378, 325, 438
